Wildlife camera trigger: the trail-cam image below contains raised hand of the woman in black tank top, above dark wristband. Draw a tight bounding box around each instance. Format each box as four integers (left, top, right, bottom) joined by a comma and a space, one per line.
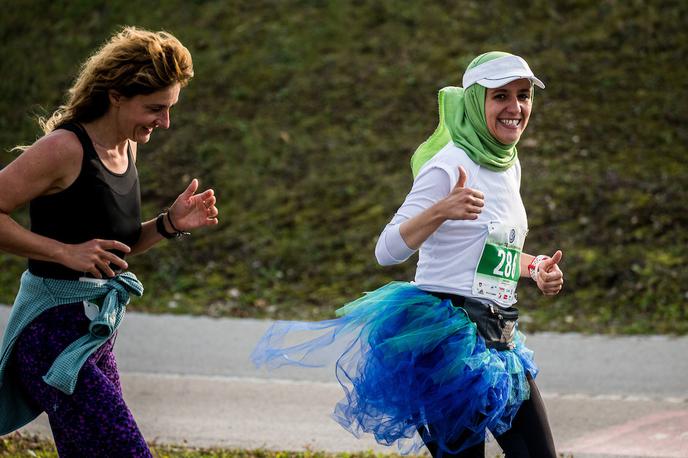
168, 178, 219, 231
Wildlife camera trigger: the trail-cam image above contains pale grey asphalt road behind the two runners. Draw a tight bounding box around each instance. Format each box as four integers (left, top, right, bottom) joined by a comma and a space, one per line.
0, 307, 688, 458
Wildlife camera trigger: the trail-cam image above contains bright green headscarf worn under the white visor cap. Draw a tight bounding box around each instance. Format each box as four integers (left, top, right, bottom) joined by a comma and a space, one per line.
411, 51, 518, 178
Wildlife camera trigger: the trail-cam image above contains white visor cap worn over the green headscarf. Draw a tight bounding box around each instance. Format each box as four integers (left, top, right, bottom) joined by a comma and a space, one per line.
463, 56, 545, 89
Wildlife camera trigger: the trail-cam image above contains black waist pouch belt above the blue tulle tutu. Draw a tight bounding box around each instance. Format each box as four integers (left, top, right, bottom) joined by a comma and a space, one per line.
430, 293, 518, 351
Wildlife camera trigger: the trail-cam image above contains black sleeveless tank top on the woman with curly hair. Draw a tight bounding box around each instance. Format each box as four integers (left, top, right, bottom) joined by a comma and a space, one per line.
29, 123, 141, 280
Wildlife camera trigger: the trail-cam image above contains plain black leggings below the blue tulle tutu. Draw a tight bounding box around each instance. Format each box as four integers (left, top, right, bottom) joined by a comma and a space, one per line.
426, 376, 557, 458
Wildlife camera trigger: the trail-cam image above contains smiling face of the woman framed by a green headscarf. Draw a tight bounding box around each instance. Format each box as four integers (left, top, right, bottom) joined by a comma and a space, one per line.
485, 78, 532, 145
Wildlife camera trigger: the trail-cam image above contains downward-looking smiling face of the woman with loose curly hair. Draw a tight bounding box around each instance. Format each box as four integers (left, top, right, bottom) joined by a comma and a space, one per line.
112, 83, 181, 143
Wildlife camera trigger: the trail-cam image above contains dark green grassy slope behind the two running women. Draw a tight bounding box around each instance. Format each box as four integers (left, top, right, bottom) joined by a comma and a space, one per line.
0, 0, 688, 333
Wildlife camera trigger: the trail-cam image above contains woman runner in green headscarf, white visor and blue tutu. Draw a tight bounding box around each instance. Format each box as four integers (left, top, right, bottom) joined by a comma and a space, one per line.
253, 52, 563, 458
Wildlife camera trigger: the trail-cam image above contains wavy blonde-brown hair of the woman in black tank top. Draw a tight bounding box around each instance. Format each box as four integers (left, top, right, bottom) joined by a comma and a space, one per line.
38, 27, 193, 134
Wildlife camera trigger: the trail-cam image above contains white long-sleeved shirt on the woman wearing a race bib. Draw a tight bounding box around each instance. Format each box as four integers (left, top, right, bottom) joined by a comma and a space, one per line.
375, 142, 528, 306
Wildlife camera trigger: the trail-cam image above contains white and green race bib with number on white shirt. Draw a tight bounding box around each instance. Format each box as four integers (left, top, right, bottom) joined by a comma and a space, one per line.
472, 222, 528, 305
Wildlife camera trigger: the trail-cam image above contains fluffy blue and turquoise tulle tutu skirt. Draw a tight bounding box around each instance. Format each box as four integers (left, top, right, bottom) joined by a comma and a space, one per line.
251, 282, 538, 453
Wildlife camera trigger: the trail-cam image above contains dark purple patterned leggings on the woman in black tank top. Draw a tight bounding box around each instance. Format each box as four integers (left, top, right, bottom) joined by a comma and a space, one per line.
10, 302, 151, 458
